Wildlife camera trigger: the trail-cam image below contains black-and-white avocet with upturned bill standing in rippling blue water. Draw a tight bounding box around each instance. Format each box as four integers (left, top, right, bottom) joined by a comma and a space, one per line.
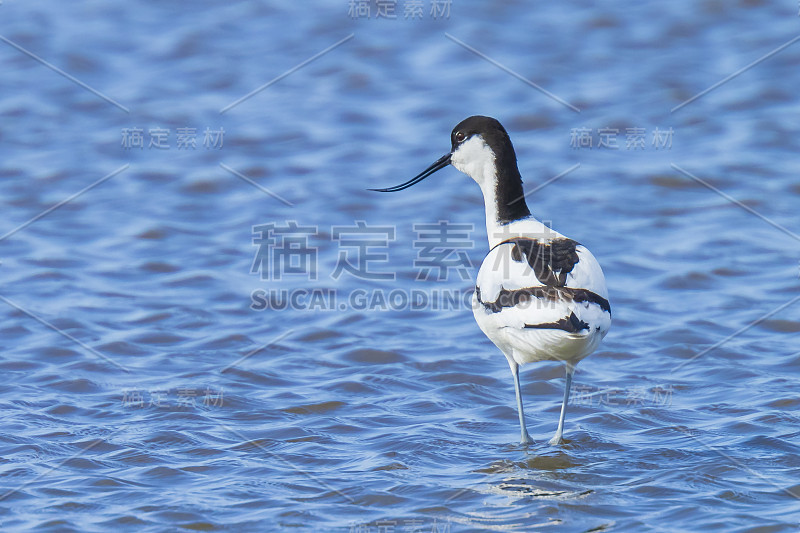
372, 116, 611, 445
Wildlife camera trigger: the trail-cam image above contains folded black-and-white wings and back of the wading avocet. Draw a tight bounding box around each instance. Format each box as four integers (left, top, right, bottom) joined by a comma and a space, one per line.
475, 237, 611, 360
